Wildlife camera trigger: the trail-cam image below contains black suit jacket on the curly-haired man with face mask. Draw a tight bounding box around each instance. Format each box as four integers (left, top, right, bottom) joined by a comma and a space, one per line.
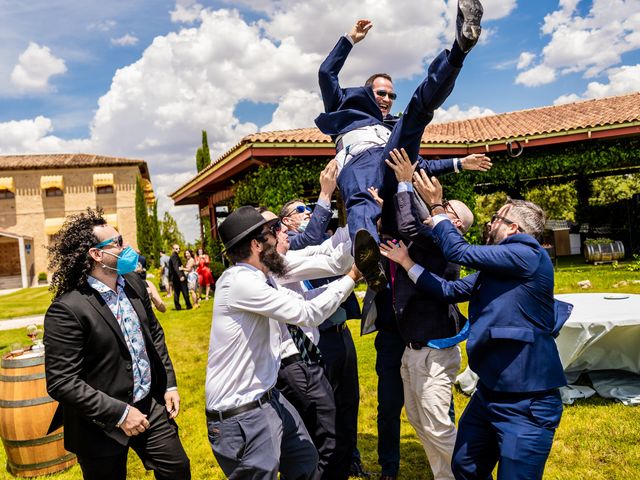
44, 273, 176, 457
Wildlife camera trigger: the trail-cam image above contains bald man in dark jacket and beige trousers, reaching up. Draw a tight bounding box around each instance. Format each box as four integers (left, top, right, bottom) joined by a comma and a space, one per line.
379, 150, 474, 480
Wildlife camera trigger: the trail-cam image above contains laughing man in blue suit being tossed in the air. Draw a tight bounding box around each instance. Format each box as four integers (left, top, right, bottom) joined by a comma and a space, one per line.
315, 0, 490, 291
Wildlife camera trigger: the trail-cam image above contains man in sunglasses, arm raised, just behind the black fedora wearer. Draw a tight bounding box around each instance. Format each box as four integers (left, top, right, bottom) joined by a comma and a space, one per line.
280, 160, 338, 250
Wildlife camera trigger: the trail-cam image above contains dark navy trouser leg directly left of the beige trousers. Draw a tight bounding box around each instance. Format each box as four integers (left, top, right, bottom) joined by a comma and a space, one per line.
375, 330, 405, 475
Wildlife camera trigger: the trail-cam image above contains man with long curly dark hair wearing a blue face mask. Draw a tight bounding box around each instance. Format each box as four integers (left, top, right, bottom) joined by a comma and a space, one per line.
44, 209, 191, 480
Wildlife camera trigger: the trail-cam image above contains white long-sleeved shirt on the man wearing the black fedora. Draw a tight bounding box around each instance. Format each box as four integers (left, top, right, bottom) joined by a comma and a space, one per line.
205, 264, 354, 410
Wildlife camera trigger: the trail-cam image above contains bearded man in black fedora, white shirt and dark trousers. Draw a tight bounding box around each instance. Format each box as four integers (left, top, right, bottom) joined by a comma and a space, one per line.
205, 206, 359, 479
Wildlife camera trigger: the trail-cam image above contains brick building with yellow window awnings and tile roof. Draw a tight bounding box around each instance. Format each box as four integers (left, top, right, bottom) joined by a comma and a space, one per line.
0, 154, 155, 288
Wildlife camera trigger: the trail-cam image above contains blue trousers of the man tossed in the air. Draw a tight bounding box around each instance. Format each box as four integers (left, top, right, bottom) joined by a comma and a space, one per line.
338, 50, 460, 241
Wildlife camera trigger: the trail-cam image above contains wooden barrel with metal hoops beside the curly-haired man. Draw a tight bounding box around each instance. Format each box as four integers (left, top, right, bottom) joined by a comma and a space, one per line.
0, 351, 76, 477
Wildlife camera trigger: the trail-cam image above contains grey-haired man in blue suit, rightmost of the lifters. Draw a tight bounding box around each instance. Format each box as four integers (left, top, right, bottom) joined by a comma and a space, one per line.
381, 172, 566, 480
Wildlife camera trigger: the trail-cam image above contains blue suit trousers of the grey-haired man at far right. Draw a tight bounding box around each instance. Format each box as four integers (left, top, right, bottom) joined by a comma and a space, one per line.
452, 383, 562, 480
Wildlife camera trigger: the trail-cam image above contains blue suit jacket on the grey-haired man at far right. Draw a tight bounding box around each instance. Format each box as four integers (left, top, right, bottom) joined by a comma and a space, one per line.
418, 221, 566, 392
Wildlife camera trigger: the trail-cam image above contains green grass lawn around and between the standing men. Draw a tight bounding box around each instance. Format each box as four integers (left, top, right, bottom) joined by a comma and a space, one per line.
0, 266, 640, 480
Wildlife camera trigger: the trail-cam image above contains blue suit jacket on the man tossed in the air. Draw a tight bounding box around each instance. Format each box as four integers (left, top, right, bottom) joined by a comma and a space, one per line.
315, 36, 454, 178
